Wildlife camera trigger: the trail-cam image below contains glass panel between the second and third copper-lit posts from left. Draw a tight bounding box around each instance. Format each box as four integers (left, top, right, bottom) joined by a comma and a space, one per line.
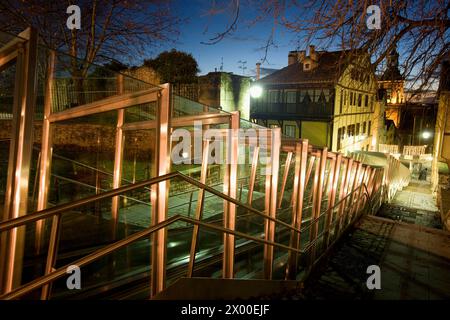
49, 111, 117, 204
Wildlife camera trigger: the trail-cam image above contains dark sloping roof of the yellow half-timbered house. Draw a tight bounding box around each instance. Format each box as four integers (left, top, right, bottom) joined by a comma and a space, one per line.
258, 50, 362, 84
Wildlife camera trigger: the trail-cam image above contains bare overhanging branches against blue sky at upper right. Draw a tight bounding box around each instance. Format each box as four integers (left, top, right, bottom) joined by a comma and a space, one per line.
204, 0, 450, 90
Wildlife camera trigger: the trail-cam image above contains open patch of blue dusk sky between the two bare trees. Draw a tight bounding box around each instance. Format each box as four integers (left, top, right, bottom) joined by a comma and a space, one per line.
152, 0, 304, 75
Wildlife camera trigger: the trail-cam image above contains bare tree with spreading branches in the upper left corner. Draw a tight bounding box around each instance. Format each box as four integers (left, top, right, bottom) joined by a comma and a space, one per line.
0, 0, 180, 78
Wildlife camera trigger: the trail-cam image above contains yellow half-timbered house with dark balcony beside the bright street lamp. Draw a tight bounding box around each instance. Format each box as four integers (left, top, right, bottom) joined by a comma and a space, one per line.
250, 46, 384, 153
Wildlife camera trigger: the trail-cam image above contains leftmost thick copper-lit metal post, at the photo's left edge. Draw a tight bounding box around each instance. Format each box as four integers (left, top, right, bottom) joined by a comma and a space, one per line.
1, 28, 38, 292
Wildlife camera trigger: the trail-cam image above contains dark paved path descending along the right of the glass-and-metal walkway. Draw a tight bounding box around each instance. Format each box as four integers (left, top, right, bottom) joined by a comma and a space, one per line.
287, 180, 450, 300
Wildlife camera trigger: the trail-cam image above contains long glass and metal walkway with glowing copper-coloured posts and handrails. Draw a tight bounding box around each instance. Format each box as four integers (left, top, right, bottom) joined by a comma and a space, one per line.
0, 29, 404, 299
